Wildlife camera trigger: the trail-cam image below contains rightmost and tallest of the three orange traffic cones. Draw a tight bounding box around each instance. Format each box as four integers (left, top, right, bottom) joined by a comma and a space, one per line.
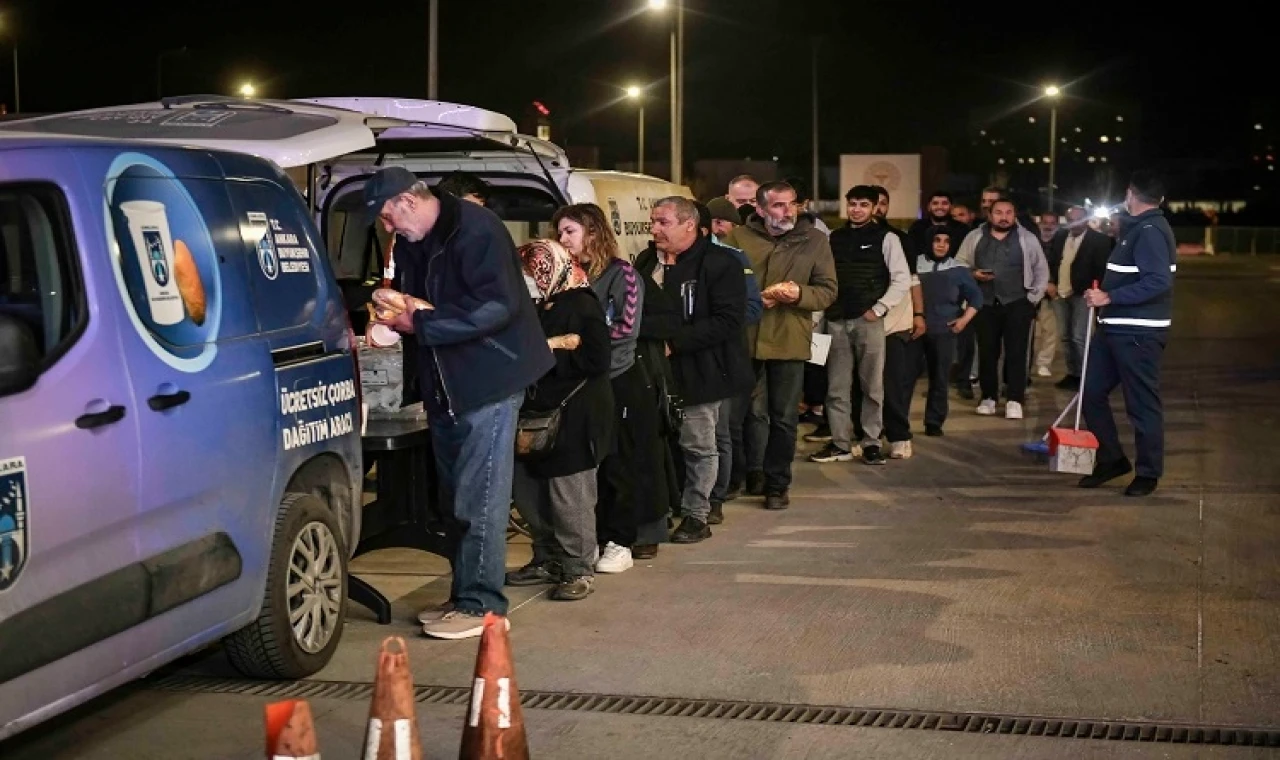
458, 613, 529, 760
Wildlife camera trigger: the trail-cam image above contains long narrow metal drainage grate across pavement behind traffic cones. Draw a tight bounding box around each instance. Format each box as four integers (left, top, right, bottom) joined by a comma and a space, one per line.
146, 676, 1280, 747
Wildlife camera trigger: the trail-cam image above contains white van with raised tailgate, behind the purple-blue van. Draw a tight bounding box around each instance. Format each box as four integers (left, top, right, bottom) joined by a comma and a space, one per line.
297, 97, 692, 281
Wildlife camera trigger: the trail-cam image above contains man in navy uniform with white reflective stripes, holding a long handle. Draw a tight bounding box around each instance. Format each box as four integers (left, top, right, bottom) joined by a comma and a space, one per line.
1080, 171, 1178, 496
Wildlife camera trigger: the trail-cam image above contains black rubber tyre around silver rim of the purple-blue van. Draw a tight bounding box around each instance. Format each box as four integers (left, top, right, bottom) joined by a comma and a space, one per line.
223, 494, 347, 679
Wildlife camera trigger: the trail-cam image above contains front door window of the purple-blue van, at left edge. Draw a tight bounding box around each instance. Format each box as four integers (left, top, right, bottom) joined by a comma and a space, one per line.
0, 184, 87, 361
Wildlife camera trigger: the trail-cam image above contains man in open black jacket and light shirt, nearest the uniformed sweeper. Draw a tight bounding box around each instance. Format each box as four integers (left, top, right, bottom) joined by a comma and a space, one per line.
1044, 206, 1114, 390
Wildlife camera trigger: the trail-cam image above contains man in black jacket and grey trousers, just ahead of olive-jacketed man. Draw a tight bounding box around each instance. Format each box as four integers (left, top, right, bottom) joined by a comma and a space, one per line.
636, 196, 755, 544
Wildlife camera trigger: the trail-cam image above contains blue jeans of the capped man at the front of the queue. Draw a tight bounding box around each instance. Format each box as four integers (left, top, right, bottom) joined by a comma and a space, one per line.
430, 393, 525, 615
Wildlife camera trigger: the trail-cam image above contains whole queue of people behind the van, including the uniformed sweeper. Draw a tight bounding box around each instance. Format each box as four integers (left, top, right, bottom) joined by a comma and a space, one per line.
365, 168, 1175, 638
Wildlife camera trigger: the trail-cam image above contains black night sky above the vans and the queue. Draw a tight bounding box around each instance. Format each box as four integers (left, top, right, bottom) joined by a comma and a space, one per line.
0, 0, 1276, 179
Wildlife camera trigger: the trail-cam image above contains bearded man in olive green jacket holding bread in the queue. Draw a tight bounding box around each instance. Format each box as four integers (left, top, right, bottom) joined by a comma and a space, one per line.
724, 182, 837, 509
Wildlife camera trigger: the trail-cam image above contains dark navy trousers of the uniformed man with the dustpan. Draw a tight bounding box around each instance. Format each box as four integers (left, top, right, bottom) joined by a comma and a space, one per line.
1082, 330, 1169, 477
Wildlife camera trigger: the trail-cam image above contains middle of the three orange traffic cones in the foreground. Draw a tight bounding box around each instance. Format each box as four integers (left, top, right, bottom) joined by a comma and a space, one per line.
365, 636, 422, 760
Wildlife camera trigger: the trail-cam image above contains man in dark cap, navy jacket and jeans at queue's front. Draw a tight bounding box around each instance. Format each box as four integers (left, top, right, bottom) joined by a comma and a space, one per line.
364, 166, 556, 638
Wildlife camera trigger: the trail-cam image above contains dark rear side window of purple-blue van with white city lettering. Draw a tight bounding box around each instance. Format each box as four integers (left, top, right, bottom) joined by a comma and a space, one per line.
229, 182, 329, 333
